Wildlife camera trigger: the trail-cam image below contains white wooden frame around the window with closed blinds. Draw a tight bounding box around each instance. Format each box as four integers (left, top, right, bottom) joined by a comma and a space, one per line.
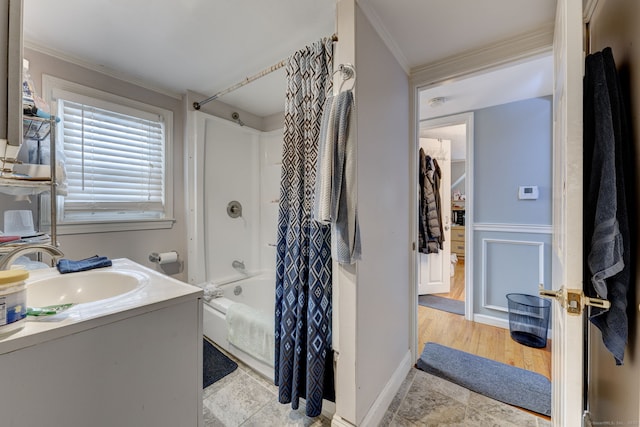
41, 74, 175, 235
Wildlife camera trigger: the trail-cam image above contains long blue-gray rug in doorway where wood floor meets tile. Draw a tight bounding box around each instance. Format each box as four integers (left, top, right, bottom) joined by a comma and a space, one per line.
416, 342, 551, 416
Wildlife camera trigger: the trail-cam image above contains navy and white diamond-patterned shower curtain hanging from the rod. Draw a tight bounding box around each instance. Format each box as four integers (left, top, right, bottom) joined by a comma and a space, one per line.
275, 39, 333, 417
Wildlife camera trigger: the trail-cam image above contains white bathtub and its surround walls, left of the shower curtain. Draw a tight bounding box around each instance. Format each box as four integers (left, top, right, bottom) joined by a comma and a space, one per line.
187, 110, 284, 379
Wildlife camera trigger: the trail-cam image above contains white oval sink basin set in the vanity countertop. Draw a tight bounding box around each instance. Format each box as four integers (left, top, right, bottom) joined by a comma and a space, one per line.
27, 270, 148, 307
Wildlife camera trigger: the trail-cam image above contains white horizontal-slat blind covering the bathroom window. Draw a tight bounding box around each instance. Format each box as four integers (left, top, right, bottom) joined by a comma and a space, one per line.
58, 98, 165, 223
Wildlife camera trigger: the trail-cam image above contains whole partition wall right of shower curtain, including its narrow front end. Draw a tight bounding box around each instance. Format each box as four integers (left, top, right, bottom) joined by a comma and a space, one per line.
334, 0, 410, 425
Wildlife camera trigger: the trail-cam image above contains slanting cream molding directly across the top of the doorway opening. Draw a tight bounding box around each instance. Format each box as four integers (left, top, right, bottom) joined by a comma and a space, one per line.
409, 24, 554, 86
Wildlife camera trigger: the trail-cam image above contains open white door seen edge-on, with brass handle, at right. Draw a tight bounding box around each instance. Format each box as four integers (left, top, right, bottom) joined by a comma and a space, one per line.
551, 0, 584, 426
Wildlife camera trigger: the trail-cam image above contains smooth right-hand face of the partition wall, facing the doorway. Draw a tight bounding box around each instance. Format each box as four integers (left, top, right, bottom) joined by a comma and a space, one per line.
355, 8, 412, 419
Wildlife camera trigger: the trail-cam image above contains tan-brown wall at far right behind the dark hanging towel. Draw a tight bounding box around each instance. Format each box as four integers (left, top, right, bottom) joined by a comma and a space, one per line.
589, 0, 640, 425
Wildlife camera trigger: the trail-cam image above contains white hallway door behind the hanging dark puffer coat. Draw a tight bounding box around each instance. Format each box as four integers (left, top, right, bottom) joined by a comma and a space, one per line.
418, 138, 451, 295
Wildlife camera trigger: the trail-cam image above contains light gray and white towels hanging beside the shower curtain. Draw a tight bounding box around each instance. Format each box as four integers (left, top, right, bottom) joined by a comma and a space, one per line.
313, 90, 361, 264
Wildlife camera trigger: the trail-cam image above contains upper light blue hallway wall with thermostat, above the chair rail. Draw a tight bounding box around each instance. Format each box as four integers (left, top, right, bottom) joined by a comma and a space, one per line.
474, 97, 552, 224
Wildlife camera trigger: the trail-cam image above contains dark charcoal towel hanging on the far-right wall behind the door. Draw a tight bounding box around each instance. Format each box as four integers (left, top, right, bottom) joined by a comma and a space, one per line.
584, 48, 635, 365
